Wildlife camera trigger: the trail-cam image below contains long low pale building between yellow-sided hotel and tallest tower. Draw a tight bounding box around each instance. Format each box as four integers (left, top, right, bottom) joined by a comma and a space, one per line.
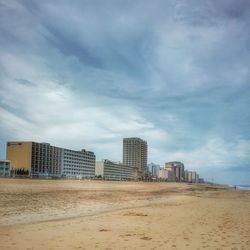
95, 160, 135, 180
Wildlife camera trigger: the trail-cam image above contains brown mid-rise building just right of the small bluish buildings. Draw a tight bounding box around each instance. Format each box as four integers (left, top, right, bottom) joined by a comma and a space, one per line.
164, 161, 184, 182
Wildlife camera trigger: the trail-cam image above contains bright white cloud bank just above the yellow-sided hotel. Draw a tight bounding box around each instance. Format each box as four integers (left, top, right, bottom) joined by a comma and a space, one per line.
0, 79, 156, 160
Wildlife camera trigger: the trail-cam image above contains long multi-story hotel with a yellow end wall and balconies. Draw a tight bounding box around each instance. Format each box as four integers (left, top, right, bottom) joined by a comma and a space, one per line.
6, 141, 95, 178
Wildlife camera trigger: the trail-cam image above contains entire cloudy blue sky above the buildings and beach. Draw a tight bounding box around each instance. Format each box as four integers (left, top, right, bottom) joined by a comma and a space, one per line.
0, 0, 250, 185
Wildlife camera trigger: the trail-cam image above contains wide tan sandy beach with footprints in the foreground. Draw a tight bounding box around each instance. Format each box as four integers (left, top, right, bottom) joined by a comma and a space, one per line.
0, 179, 250, 250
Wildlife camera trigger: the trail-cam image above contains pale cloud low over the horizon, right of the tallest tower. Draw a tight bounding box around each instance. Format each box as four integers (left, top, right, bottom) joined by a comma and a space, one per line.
150, 136, 250, 184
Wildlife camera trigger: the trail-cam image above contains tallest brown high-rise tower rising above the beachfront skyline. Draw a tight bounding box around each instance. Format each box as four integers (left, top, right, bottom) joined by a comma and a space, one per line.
123, 137, 148, 174
